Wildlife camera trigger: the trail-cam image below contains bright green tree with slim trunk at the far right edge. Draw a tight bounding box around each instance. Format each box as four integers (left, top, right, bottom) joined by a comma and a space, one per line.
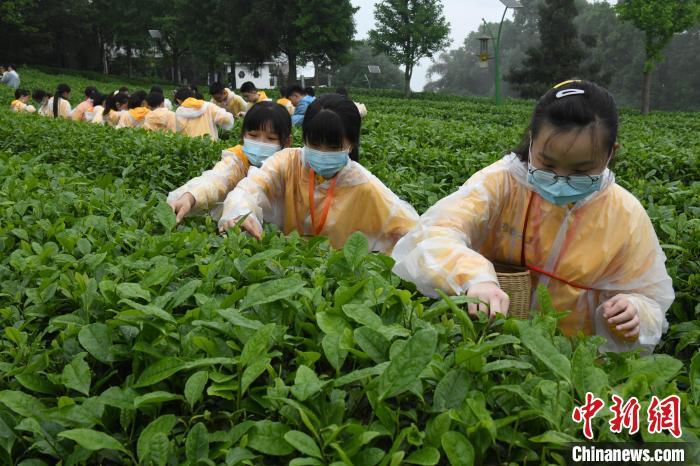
616, 0, 700, 115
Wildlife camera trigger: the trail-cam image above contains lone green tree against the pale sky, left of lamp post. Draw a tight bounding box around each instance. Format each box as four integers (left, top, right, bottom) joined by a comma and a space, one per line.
369, 0, 451, 97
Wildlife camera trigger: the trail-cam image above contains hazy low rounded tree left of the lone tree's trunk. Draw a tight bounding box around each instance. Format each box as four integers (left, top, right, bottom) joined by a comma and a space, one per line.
332, 41, 404, 89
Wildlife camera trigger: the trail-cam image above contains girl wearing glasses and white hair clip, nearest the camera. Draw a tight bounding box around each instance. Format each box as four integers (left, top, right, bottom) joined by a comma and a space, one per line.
393, 81, 674, 352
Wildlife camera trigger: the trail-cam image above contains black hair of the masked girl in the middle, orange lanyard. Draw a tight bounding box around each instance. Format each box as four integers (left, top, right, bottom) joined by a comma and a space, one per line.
302, 94, 362, 162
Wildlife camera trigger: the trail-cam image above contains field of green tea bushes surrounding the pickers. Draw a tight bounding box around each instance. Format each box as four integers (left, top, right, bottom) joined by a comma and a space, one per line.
0, 67, 700, 465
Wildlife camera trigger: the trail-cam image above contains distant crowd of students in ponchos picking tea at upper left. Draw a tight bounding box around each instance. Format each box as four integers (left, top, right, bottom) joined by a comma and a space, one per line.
10, 78, 366, 141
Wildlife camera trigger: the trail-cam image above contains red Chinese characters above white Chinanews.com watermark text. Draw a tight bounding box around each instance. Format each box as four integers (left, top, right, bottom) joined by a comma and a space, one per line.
567, 392, 697, 466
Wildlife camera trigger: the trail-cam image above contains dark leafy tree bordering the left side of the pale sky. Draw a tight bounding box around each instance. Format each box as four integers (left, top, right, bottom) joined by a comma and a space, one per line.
295, 0, 359, 87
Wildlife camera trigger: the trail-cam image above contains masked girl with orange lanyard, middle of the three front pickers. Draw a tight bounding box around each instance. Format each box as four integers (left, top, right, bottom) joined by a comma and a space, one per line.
219, 94, 418, 253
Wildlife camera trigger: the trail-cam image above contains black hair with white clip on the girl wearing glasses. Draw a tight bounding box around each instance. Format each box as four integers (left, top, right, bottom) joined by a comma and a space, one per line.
513, 80, 618, 162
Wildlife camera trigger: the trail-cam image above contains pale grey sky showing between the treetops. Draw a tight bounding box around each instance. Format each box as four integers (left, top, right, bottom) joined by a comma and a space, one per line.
351, 0, 513, 91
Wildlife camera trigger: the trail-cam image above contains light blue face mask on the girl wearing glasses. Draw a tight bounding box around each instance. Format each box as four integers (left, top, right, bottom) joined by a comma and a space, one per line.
527, 144, 603, 205
